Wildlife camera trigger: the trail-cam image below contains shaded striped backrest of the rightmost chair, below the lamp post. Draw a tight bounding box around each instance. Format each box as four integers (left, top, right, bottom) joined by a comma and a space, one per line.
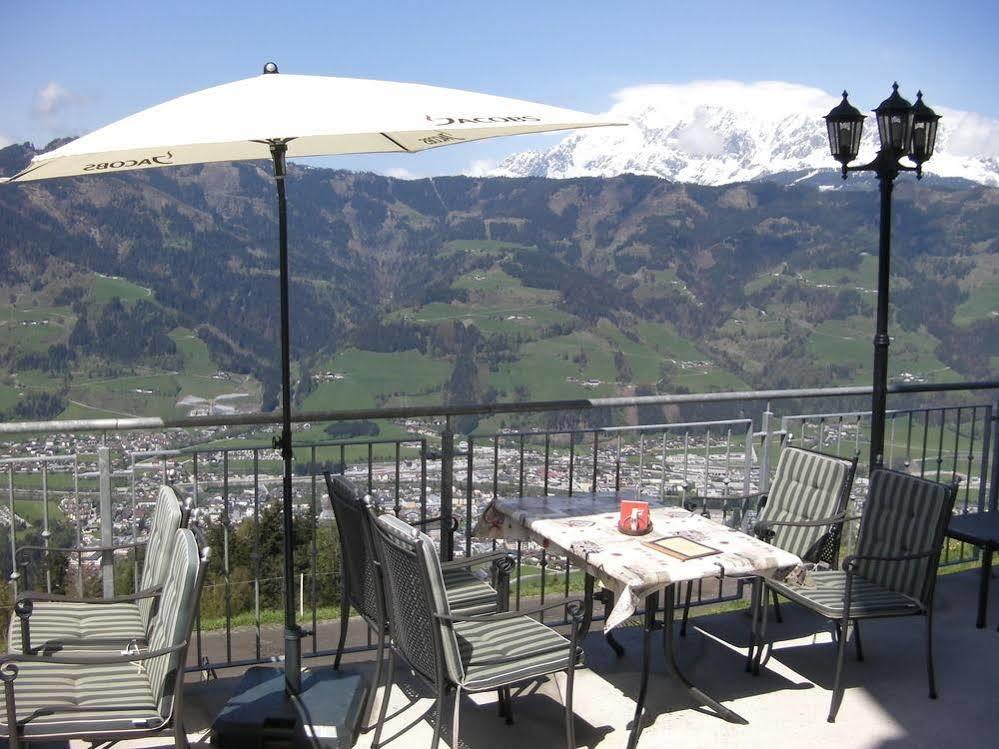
857, 468, 957, 607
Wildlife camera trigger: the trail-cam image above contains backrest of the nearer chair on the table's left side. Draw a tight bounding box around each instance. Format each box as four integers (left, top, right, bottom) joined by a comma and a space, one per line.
375, 515, 464, 685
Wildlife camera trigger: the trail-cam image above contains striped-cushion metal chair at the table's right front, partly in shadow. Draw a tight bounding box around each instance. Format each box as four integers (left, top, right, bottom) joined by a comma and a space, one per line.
753, 469, 957, 723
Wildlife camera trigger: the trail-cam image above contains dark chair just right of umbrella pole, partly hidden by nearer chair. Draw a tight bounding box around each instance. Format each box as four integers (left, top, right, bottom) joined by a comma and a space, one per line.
323, 471, 514, 732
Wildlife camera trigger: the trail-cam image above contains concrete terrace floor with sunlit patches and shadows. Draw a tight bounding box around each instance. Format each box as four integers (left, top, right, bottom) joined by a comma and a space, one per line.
74, 570, 999, 749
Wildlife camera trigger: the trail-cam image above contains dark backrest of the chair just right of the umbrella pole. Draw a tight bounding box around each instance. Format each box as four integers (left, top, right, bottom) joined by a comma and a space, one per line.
324, 471, 384, 629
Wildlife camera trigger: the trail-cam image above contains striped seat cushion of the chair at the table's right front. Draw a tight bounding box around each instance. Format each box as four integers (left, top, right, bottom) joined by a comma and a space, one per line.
767, 570, 922, 619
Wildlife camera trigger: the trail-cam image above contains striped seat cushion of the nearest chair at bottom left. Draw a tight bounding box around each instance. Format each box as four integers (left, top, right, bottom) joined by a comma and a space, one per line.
0, 663, 164, 736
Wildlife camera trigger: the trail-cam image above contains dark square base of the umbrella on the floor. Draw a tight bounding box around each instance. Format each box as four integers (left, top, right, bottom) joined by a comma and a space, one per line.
211, 666, 368, 749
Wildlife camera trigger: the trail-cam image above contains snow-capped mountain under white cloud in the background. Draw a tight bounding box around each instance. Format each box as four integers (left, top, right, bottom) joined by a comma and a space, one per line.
491, 81, 999, 185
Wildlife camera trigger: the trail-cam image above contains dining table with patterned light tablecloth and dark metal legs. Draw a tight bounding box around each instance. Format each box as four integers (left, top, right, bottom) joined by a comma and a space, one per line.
473, 492, 801, 749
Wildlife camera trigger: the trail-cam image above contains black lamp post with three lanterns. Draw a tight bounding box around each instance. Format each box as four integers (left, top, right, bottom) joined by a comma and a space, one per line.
825, 83, 940, 469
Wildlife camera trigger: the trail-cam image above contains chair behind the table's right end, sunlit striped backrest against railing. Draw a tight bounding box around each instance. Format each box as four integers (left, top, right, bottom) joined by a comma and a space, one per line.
680, 446, 857, 636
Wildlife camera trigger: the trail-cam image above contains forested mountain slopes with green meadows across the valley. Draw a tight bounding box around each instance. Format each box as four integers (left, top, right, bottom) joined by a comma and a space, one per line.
0, 140, 999, 426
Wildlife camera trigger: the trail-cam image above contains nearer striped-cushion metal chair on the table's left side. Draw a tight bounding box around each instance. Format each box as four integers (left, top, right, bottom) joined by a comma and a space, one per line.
374, 515, 583, 749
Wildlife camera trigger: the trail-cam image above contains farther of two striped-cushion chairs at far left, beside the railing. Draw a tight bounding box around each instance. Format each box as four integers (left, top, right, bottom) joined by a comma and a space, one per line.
7, 486, 190, 653
